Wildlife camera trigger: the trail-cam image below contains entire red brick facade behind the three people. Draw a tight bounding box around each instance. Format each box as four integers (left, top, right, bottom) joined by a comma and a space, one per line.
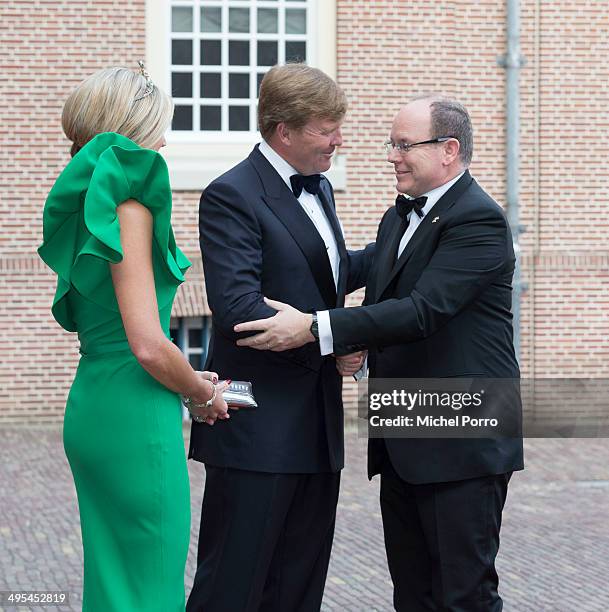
0, 0, 609, 422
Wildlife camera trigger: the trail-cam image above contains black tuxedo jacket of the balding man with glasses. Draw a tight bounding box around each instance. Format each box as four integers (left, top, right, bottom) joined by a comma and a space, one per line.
330, 171, 523, 484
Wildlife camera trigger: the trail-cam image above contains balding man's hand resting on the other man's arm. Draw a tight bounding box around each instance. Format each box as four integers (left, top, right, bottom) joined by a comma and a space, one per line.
234, 298, 315, 352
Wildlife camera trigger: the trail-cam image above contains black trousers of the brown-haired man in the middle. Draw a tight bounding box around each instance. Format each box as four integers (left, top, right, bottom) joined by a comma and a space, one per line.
186, 465, 340, 612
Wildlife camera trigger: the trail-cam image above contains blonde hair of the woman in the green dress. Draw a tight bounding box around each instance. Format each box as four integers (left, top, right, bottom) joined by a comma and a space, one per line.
61, 68, 173, 156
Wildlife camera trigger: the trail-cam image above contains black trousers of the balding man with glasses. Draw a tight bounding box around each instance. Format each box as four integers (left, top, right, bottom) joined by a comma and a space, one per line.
380, 458, 511, 612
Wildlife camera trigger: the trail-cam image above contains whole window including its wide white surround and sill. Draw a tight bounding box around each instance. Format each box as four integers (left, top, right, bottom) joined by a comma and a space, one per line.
146, 0, 346, 191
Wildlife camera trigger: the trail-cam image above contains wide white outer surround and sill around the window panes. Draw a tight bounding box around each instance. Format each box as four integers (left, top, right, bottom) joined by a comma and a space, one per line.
146, 0, 346, 191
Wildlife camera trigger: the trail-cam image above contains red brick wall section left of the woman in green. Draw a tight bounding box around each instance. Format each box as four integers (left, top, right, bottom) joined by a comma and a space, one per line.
0, 0, 145, 422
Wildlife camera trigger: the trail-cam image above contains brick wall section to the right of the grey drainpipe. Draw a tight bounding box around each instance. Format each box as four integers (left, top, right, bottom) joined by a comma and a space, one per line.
522, 2, 609, 378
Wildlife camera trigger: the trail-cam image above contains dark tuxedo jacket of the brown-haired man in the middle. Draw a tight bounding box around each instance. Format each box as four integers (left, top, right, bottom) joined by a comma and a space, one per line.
189, 147, 374, 473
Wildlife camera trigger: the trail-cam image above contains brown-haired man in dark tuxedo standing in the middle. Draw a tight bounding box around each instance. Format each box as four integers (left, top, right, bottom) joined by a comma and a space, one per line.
187, 64, 374, 612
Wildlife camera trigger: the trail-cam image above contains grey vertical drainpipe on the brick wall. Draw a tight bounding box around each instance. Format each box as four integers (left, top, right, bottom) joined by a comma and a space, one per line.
499, 0, 525, 360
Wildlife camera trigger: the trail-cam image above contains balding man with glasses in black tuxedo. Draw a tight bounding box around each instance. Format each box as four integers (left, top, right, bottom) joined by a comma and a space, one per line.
237, 96, 523, 612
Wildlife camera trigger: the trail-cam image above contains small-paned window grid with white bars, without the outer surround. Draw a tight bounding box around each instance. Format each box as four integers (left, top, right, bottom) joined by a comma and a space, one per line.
169, 0, 313, 138
